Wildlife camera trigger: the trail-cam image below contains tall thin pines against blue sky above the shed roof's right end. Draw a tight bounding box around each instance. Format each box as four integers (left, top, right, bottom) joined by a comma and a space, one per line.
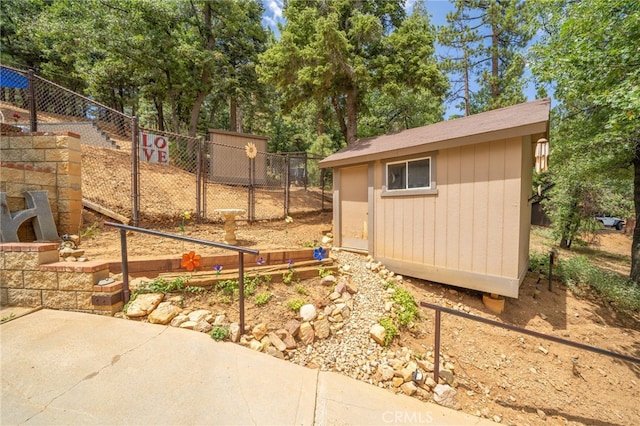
438, 0, 537, 115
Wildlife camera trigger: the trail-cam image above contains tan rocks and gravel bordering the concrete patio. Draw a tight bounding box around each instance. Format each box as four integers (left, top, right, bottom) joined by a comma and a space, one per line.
120, 249, 461, 409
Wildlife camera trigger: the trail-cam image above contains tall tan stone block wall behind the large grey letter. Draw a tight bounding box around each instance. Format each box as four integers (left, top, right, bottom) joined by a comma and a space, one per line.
0, 132, 82, 241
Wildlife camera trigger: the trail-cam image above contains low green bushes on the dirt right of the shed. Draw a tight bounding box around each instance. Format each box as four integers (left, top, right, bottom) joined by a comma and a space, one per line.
555, 256, 640, 312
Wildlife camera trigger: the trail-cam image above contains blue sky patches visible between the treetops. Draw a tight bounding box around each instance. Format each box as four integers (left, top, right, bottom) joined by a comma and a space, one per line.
262, 0, 536, 117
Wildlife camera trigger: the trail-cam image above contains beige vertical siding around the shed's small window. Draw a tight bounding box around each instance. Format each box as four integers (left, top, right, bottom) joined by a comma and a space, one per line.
372, 137, 531, 292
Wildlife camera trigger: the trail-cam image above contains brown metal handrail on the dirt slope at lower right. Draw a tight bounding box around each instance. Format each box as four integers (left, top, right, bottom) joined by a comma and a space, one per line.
420, 302, 640, 383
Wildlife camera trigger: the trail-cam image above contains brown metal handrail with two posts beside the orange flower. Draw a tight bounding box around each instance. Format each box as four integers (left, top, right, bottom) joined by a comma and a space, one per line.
104, 222, 260, 333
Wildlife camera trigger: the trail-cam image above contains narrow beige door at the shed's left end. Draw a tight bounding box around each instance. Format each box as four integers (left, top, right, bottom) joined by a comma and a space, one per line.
340, 165, 369, 250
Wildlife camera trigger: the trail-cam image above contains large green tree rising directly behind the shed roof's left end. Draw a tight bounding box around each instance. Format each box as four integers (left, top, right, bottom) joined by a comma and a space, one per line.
258, 0, 446, 144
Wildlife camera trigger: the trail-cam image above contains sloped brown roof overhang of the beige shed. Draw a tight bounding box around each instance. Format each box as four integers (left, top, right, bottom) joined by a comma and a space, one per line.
320, 98, 551, 167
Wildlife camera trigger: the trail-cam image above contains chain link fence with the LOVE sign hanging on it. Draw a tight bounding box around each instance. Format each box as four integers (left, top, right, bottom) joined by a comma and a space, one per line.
0, 66, 331, 225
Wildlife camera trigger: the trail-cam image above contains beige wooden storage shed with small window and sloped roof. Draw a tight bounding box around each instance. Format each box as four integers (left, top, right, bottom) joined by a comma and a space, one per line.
320, 99, 550, 297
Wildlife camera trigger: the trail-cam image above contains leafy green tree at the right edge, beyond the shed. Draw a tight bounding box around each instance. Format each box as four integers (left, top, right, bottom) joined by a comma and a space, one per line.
531, 0, 640, 283
